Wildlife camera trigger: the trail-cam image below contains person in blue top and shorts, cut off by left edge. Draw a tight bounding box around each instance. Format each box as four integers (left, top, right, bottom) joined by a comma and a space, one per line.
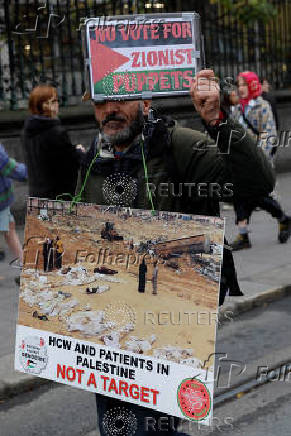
0, 144, 27, 267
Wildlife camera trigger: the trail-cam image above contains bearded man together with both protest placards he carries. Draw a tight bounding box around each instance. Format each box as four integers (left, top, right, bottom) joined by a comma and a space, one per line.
15, 14, 274, 436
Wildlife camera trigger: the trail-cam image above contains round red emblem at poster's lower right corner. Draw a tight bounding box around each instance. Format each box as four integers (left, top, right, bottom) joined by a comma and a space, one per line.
177, 378, 211, 421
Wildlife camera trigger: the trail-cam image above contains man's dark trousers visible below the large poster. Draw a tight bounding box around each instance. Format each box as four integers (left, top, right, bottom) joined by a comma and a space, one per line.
96, 394, 184, 436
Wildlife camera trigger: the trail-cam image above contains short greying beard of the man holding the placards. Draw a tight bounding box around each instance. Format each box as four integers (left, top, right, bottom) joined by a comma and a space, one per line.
100, 104, 144, 146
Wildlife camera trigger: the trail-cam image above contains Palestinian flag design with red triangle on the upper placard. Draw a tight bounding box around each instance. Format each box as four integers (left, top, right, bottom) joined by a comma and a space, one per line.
90, 22, 196, 96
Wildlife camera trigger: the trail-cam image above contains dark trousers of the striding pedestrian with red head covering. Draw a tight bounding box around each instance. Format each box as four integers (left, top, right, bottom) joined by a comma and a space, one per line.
234, 195, 284, 223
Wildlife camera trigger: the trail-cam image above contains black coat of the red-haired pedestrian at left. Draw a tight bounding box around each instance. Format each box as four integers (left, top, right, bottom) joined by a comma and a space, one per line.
22, 115, 79, 199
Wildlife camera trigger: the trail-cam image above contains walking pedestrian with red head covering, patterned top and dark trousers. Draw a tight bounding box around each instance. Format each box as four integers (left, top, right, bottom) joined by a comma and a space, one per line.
232, 71, 291, 250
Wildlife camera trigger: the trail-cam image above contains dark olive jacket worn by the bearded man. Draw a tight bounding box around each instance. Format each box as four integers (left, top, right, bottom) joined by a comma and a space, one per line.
77, 119, 275, 215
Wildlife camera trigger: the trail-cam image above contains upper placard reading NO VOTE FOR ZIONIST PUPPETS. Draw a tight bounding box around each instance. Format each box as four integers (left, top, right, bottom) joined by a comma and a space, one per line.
85, 13, 201, 101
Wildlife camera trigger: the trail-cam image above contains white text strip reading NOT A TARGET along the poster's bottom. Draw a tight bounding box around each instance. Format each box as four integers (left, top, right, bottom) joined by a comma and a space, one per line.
14, 324, 215, 426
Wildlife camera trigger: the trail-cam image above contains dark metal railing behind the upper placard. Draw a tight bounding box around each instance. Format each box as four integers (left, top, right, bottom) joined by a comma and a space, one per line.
0, 0, 291, 109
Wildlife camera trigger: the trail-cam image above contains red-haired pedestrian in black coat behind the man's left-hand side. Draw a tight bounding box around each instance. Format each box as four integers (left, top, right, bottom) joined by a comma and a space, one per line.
22, 85, 82, 200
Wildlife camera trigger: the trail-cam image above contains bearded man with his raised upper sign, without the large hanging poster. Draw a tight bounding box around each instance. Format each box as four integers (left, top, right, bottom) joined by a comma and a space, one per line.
79, 14, 274, 435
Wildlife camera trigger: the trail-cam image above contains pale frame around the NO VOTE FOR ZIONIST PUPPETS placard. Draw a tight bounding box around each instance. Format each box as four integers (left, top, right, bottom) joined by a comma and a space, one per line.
83, 12, 204, 103
